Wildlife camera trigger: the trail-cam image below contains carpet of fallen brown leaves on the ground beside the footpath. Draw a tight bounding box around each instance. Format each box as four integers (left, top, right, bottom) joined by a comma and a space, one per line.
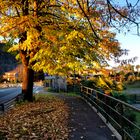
0, 96, 69, 140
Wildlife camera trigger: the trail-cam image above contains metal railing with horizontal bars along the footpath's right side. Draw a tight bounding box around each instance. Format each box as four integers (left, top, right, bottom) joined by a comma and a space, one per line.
80, 86, 140, 140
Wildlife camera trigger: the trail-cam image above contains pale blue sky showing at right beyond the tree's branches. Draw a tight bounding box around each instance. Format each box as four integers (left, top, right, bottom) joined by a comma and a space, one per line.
110, 0, 140, 66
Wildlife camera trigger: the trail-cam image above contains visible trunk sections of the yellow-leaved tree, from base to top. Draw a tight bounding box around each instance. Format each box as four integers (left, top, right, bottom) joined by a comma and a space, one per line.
20, 0, 37, 101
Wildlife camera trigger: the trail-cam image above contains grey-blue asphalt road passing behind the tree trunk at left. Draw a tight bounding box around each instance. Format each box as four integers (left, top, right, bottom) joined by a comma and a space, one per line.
0, 86, 43, 103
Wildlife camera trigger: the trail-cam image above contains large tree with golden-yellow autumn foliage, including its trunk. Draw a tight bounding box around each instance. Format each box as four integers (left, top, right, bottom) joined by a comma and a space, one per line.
0, 0, 137, 101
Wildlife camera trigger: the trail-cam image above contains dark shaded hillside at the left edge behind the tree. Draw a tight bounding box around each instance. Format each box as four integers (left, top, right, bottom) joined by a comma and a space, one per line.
0, 43, 17, 75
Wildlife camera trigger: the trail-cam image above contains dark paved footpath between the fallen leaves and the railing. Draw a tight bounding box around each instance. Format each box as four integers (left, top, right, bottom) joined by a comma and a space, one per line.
49, 94, 117, 140
